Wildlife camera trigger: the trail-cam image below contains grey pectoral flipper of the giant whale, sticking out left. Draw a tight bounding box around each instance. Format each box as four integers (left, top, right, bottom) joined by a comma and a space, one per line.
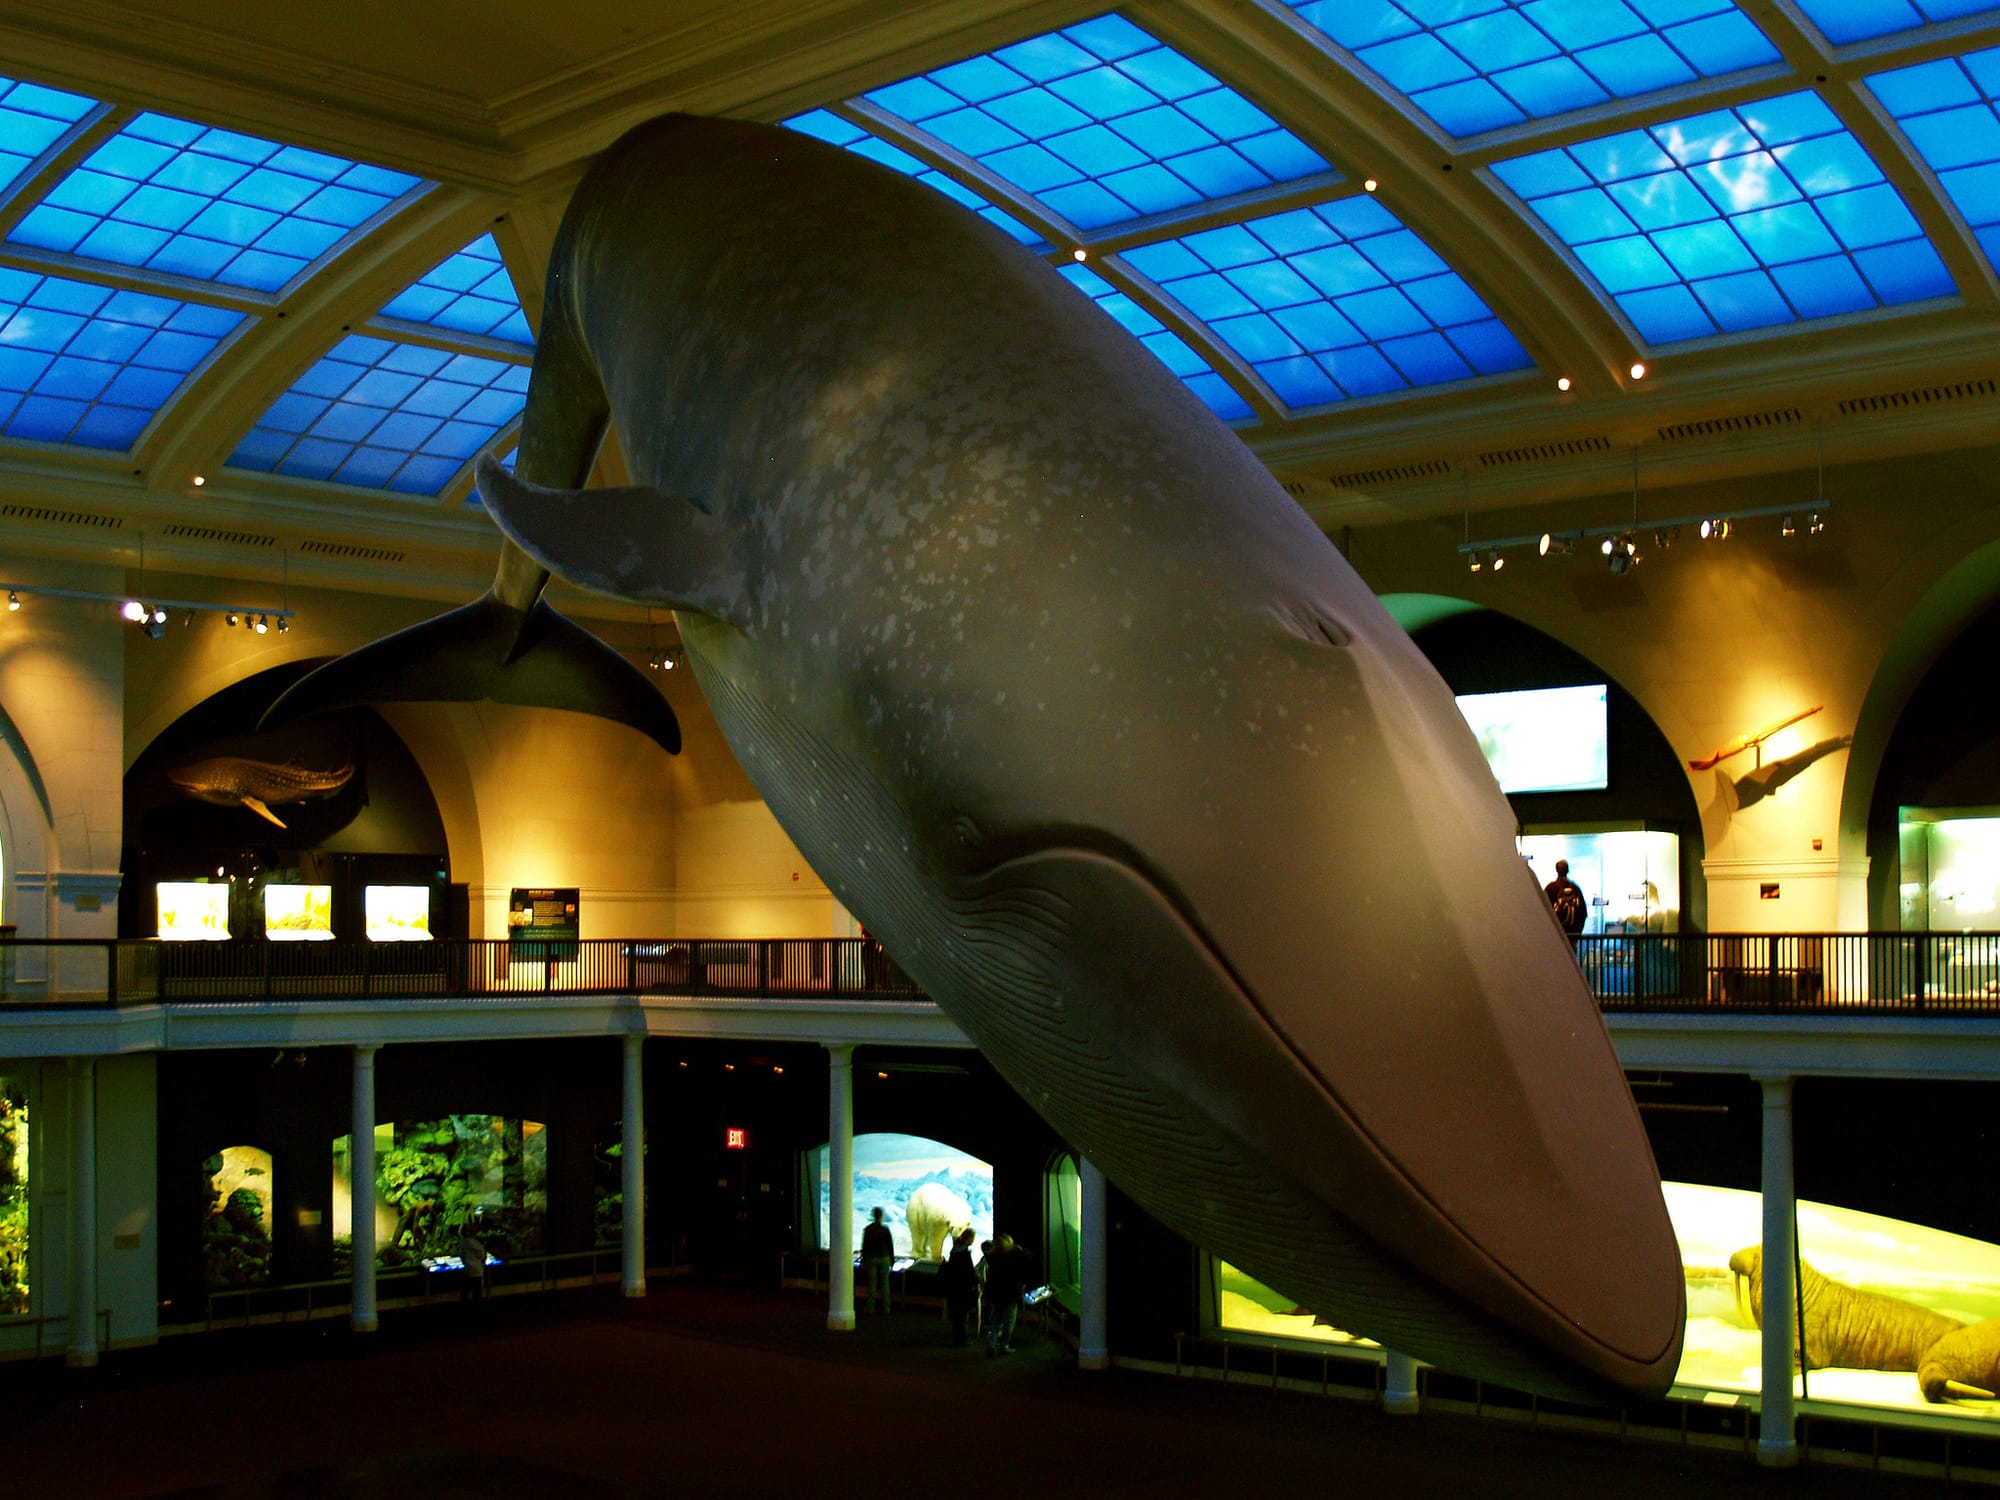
478, 456, 748, 630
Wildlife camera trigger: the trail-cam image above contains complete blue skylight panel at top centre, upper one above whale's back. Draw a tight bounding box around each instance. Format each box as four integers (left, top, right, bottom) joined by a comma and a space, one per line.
868, 16, 1330, 230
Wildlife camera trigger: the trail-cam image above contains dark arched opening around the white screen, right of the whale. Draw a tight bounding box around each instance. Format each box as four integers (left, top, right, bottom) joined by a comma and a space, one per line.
1382, 594, 1708, 932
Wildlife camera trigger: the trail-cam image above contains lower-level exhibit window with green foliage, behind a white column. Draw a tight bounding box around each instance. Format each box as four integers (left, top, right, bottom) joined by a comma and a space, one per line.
332, 1114, 548, 1274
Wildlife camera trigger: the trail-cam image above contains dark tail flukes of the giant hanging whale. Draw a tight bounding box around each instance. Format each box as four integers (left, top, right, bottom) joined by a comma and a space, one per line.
258, 594, 680, 754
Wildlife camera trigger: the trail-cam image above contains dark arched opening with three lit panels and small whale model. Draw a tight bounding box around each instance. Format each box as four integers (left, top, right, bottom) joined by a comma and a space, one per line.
120, 662, 466, 940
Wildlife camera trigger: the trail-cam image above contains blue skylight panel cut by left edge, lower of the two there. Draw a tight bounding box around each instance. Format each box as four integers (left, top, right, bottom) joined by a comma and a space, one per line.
0, 268, 244, 452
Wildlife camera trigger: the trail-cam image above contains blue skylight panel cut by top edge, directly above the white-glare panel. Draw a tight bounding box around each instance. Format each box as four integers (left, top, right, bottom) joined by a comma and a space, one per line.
1286, 0, 1778, 136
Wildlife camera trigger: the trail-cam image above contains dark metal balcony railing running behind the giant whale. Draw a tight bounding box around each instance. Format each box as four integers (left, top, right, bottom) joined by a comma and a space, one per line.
0, 932, 2000, 1016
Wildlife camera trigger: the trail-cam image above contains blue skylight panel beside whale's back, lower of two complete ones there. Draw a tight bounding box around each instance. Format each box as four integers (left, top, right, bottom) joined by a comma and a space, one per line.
1122, 198, 1532, 410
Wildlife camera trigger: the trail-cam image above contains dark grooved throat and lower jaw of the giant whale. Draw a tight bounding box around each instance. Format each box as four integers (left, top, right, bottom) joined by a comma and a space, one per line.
688, 630, 1678, 1400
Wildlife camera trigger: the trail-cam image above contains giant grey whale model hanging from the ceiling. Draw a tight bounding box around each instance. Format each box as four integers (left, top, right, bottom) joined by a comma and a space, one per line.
274, 116, 1682, 1398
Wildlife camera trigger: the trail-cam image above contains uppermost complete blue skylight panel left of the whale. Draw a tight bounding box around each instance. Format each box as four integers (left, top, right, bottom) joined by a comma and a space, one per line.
8, 114, 418, 292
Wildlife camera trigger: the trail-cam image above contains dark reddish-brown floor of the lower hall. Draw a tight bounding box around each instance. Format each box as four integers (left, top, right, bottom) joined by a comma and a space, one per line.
0, 1280, 1952, 1500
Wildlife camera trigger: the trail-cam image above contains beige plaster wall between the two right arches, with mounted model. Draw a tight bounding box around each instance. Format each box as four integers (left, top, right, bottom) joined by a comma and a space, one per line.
1350, 450, 2000, 932
